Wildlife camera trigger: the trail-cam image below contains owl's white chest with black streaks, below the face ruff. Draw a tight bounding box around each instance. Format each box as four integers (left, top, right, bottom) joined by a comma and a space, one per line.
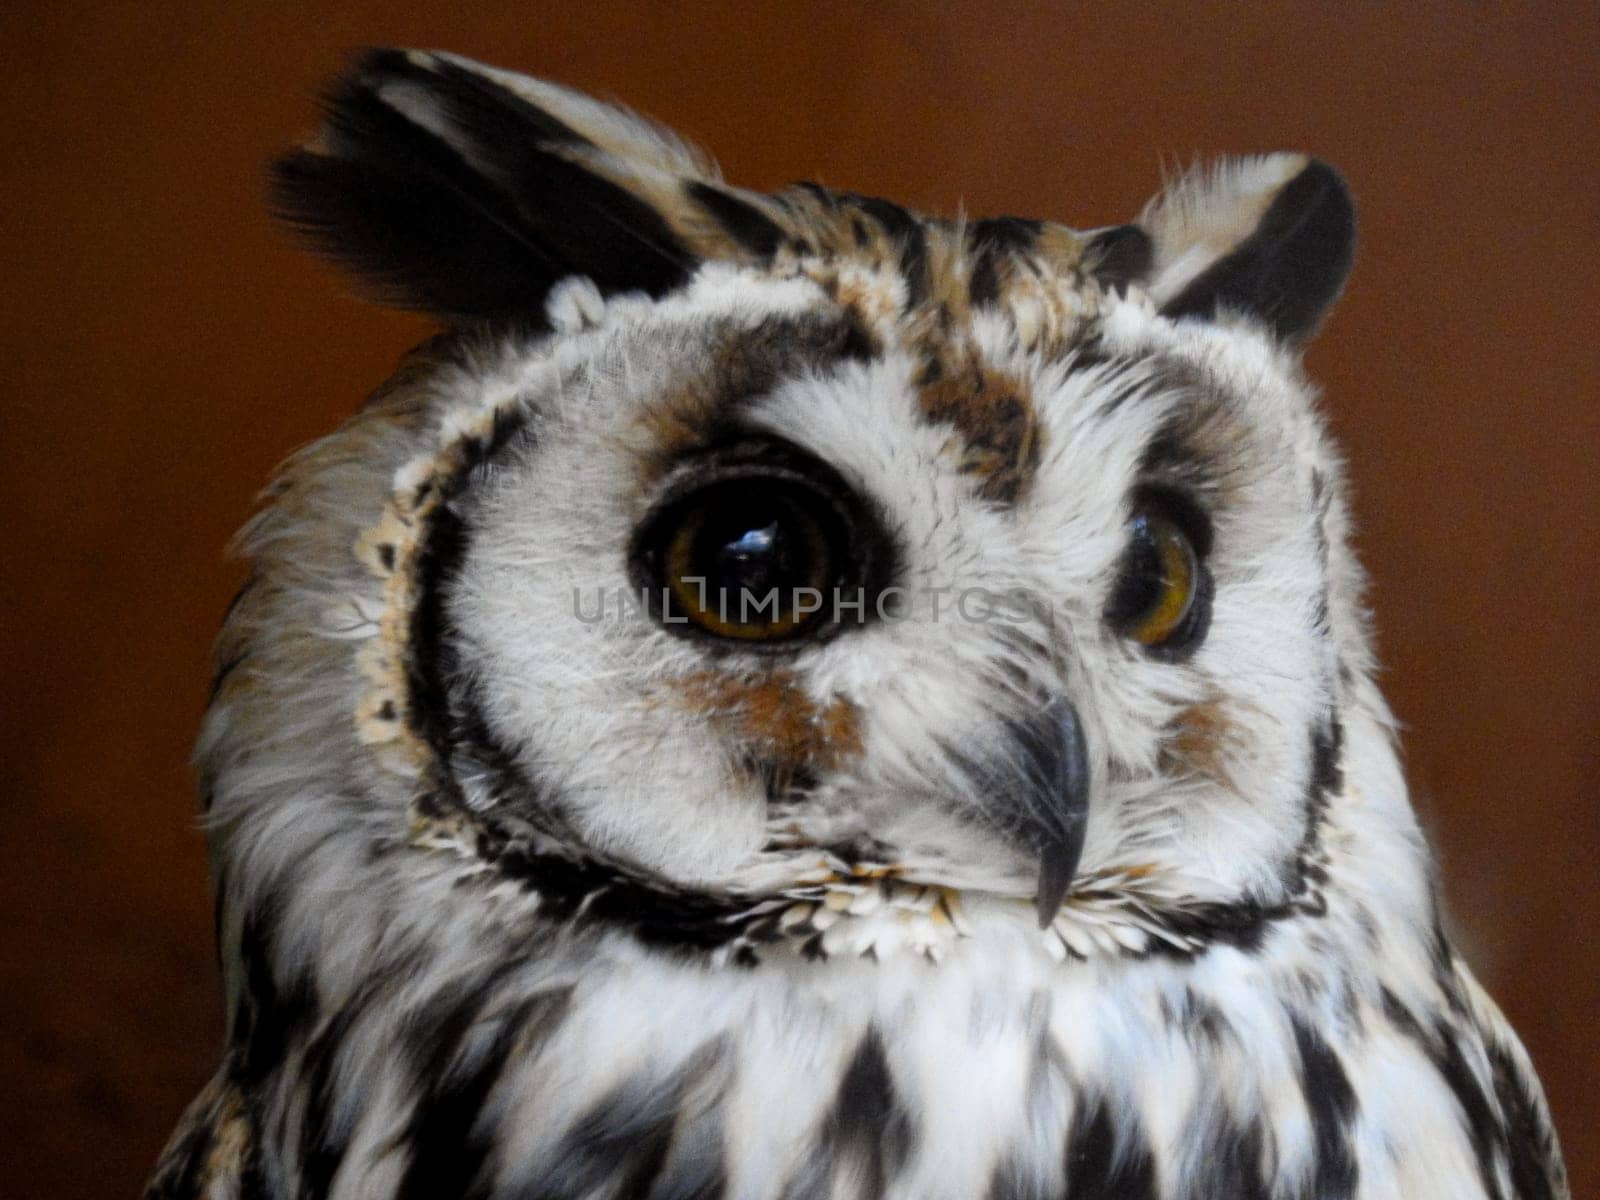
294, 942, 1504, 1200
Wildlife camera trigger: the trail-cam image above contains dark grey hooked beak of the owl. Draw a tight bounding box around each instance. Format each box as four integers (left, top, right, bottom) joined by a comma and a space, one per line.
1002, 696, 1090, 930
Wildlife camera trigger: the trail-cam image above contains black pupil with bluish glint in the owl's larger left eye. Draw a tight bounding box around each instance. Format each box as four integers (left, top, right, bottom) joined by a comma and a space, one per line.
693, 488, 818, 624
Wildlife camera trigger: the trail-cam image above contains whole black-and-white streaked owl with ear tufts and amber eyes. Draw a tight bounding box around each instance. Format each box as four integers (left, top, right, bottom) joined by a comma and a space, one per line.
149, 50, 1568, 1200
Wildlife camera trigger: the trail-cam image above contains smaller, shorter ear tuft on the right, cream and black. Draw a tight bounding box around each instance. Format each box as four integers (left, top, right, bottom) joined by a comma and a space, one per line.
1139, 154, 1355, 342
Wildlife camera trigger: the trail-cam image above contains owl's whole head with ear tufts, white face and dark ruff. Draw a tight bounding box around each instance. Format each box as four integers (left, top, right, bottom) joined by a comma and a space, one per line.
202, 51, 1371, 966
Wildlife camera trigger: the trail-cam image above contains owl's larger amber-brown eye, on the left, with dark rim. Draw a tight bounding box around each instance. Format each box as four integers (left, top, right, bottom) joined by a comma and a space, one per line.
634, 444, 862, 643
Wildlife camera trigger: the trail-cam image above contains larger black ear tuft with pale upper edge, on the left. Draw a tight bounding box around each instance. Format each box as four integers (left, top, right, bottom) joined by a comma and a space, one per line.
270, 50, 715, 318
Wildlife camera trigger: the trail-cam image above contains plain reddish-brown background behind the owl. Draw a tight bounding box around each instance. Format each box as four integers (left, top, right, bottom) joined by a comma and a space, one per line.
0, 0, 1600, 1197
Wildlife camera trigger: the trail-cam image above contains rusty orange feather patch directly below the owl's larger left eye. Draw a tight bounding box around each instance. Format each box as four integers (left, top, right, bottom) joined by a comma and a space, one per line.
674, 670, 861, 771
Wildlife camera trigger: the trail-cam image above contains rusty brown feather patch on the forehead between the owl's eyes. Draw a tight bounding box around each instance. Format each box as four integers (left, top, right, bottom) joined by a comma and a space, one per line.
918, 363, 1040, 504
